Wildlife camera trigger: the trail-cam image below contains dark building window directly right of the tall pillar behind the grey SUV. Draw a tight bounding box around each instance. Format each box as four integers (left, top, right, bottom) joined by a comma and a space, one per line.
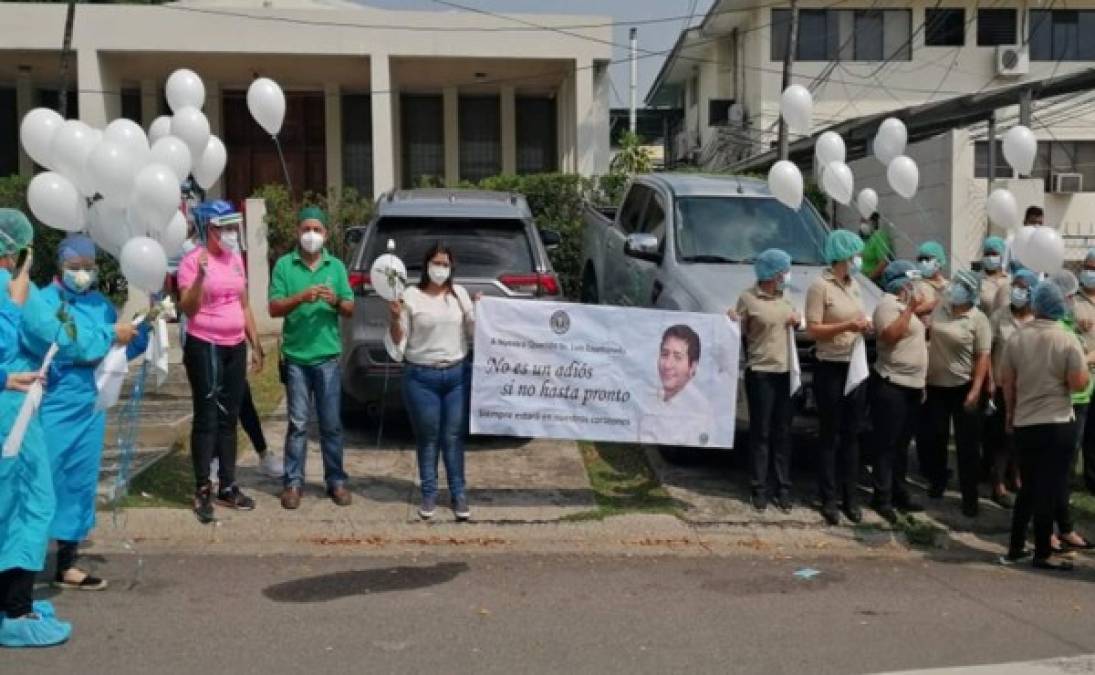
400, 94, 445, 187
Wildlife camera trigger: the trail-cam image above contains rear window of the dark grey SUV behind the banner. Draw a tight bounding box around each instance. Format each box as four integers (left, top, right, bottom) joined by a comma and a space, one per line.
358, 217, 535, 278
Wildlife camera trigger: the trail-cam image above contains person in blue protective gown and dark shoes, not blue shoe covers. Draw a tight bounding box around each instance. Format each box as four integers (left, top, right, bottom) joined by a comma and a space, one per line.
24, 234, 148, 591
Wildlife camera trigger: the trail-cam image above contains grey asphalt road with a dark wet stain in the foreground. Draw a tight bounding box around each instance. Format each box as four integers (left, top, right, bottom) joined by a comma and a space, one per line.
8, 552, 1095, 675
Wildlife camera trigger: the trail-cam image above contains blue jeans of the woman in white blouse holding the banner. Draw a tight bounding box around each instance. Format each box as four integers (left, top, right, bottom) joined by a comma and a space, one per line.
403, 361, 471, 499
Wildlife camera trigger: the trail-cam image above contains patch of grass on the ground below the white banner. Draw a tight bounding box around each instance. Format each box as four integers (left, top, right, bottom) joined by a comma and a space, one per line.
564, 442, 680, 520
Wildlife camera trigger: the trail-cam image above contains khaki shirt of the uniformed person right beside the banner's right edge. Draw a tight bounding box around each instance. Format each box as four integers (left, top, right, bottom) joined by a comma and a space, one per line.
735, 286, 795, 373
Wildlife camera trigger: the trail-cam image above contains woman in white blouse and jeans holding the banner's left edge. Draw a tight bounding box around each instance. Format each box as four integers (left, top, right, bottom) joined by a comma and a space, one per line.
384, 242, 479, 520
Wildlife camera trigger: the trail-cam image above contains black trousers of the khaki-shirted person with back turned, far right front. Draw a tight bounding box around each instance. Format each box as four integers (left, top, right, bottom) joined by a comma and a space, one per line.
1011, 422, 1076, 560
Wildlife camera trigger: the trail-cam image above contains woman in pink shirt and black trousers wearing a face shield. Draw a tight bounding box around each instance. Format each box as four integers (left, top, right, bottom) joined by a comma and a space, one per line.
178, 199, 263, 523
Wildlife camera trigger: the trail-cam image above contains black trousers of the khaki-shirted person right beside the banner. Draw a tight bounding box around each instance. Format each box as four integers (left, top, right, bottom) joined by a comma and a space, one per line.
746, 370, 791, 496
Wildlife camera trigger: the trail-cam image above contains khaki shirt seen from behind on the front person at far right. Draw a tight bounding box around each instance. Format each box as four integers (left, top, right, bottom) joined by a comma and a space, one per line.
1004, 319, 1086, 426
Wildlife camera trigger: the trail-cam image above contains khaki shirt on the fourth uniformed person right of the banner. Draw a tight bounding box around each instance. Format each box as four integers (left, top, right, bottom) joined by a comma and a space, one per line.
927, 302, 992, 387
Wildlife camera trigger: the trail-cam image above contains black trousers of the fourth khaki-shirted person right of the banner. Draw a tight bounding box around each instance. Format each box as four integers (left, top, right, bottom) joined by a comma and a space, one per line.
922, 384, 984, 505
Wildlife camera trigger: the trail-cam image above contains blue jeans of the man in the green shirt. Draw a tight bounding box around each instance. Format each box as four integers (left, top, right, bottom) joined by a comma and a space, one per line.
285, 358, 346, 490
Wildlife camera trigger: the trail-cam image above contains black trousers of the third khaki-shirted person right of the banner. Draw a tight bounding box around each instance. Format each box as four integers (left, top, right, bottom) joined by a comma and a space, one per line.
871, 373, 923, 507
